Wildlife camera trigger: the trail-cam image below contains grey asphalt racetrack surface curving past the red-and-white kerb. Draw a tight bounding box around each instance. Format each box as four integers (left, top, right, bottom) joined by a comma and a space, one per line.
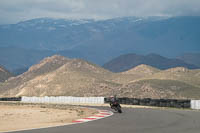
10, 107, 200, 133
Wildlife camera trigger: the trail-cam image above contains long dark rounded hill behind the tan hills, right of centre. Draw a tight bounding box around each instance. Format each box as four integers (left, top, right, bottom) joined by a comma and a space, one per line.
103, 54, 199, 72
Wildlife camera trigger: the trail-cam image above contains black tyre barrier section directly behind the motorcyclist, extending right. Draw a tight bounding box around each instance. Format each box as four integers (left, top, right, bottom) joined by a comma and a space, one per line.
105, 97, 191, 108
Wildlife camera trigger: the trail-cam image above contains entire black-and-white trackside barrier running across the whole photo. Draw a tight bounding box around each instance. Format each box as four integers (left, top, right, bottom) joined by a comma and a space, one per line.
0, 96, 200, 109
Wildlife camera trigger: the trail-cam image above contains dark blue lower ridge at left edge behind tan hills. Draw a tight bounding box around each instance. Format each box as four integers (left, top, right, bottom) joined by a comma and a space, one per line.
0, 47, 54, 75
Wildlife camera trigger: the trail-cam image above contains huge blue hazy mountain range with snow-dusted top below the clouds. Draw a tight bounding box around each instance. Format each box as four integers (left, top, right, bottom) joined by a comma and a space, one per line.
0, 16, 200, 73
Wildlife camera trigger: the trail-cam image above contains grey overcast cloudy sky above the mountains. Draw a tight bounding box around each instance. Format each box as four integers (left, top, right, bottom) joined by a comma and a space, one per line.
0, 0, 200, 24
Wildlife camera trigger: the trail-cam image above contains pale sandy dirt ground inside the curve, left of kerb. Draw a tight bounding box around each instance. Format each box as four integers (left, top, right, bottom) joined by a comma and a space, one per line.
0, 102, 97, 132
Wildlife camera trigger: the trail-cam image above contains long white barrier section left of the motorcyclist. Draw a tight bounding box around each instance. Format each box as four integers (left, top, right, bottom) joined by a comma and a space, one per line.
22, 96, 104, 104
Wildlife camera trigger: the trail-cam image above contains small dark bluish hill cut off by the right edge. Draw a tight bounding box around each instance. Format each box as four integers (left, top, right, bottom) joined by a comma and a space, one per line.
177, 53, 200, 67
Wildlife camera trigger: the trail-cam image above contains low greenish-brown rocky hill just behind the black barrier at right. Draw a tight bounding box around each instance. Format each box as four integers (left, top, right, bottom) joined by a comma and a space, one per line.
123, 79, 200, 99
